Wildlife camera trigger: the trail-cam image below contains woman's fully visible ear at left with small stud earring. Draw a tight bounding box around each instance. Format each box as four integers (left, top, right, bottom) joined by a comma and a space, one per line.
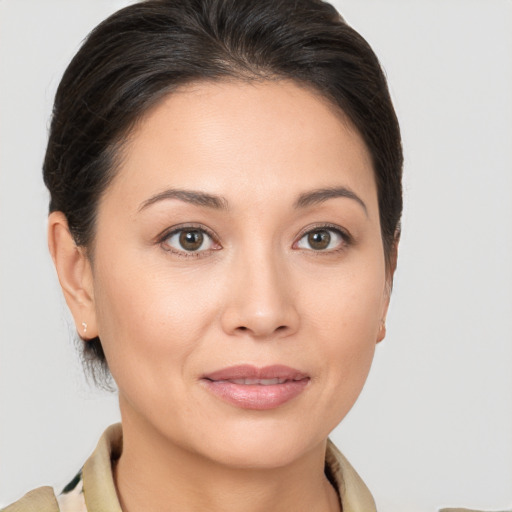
48, 212, 98, 340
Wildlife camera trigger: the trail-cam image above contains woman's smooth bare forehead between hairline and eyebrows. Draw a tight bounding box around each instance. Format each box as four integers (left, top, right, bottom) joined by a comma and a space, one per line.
105, 81, 376, 214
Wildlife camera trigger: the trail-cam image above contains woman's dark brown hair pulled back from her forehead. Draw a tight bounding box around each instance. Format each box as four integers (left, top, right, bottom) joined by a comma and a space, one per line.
43, 0, 403, 380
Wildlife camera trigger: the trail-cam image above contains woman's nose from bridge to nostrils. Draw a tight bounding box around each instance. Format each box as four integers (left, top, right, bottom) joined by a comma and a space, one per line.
221, 248, 300, 340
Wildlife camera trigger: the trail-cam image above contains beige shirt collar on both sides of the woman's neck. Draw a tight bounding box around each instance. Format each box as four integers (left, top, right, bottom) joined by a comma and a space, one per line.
82, 423, 376, 512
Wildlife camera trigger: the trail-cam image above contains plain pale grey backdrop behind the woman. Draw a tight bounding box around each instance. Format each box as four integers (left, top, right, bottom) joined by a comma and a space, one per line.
0, 0, 512, 512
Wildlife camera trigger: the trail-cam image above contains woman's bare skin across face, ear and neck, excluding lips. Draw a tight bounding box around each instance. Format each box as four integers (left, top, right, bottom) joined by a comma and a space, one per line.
49, 81, 392, 512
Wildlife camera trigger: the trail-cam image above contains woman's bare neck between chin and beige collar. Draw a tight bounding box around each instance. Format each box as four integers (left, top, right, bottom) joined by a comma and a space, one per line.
114, 406, 340, 512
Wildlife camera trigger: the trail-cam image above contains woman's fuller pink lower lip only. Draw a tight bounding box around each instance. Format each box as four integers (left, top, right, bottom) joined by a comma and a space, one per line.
203, 378, 309, 411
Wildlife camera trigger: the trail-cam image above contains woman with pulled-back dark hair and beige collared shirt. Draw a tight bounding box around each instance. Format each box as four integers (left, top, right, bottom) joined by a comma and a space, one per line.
6, 0, 402, 512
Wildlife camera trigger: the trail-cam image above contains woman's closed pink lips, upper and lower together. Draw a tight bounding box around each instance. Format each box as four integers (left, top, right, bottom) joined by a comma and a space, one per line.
202, 365, 310, 410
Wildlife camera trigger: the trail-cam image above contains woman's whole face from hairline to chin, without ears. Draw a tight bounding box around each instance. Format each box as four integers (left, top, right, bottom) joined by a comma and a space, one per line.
90, 81, 388, 467
